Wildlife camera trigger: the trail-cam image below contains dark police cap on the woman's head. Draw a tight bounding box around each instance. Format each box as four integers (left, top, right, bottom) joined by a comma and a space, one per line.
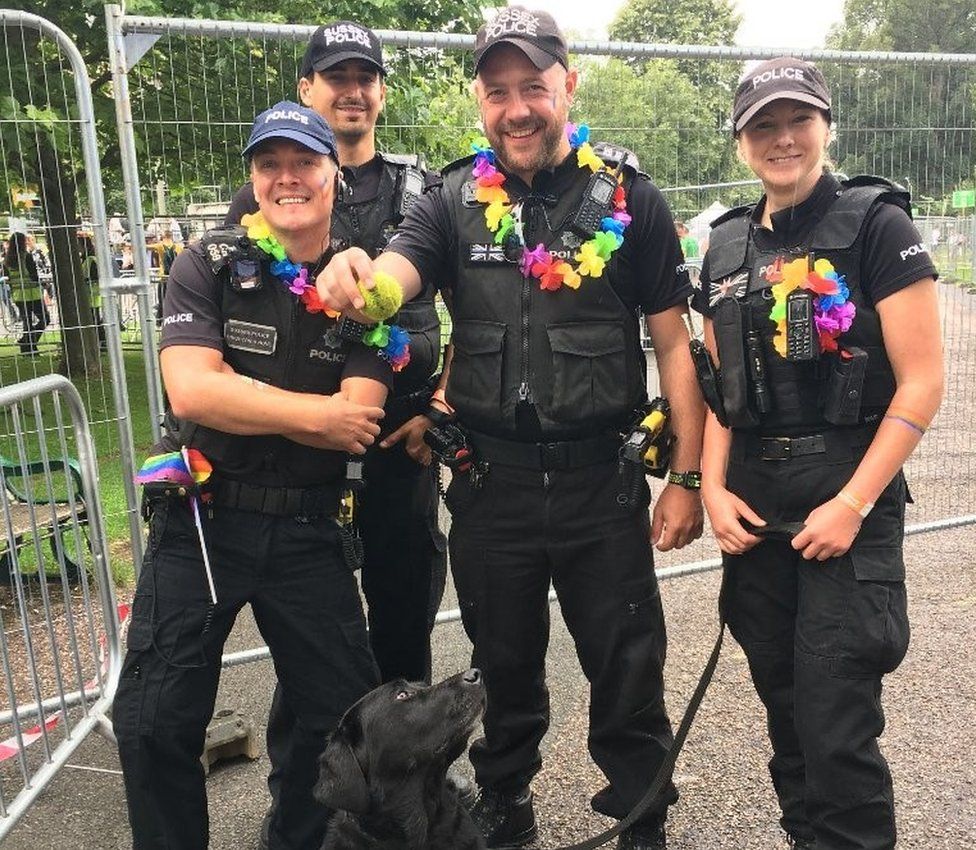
732, 56, 830, 133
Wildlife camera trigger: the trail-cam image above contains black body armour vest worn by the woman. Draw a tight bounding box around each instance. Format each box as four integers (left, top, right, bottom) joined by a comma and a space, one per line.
708, 178, 909, 434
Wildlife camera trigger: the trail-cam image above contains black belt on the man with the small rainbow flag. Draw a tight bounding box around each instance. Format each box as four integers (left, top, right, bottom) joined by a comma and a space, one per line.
143, 476, 341, 517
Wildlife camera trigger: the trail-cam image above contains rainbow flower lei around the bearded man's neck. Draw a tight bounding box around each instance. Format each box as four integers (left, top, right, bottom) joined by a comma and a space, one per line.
471, 124, 631, 292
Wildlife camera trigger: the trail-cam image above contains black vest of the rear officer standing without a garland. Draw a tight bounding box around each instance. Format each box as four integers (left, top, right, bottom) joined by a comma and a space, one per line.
331, 154, 441, 397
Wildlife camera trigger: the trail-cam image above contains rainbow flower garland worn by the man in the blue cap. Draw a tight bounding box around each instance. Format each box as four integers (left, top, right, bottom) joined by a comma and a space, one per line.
241, 212, 410, 372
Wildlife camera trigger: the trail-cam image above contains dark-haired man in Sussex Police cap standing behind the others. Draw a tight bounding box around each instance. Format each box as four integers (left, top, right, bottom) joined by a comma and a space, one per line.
227, 21, 447, 840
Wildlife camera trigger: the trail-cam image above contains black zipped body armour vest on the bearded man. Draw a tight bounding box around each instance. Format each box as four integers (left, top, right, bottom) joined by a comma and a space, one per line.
444, 148, 646, 438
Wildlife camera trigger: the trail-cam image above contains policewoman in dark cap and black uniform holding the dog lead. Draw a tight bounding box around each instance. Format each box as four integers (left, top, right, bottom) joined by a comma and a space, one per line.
698, 57, 942, 850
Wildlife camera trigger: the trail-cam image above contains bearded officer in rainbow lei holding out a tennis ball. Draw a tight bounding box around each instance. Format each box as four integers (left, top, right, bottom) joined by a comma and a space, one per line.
319, 7, 704, 848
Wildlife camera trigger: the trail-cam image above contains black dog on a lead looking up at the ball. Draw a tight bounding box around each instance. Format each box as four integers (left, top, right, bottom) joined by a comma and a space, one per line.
315, 670, 485, 850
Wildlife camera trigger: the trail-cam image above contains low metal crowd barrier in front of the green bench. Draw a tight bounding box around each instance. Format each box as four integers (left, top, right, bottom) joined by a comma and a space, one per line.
0, 375, 121, 841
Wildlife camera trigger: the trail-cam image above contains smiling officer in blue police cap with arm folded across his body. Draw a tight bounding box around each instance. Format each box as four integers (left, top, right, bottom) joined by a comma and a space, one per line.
113, 102, 392, 850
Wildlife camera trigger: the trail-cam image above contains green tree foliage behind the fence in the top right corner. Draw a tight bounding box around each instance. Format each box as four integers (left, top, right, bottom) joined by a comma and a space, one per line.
823, 0, 976, 198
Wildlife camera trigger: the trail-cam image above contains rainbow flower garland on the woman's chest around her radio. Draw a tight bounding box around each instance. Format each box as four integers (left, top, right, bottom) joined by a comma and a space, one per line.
766, 257, 857, 357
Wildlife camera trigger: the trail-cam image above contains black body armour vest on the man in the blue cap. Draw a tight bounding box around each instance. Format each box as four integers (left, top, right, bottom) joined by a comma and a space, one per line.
166, 235, 352, 487
